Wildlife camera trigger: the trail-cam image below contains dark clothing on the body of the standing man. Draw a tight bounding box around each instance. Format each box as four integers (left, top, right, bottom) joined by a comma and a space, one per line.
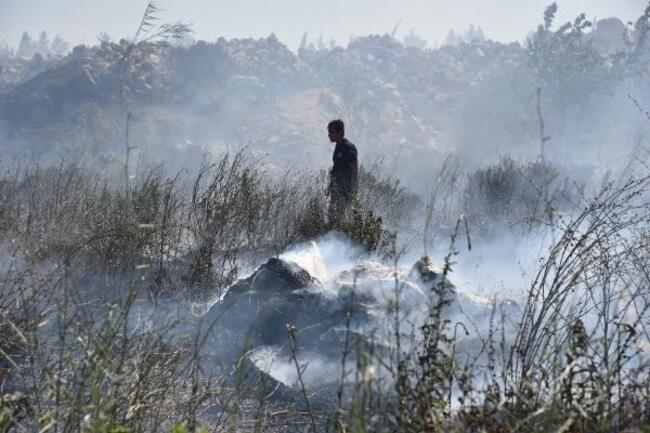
330, 139, 359, 202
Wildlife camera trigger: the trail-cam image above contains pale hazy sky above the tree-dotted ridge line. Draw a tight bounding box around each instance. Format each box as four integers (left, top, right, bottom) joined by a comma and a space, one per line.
0, 0, 648, 48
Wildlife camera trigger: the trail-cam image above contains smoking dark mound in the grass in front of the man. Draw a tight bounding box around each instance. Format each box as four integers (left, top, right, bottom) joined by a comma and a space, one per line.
203, 250, 515, 393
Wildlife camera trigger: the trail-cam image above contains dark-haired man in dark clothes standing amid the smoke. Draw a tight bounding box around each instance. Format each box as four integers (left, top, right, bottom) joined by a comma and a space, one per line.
327, 119, 359, 227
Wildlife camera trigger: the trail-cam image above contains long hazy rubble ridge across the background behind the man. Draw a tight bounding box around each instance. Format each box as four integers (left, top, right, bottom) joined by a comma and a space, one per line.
0, 20, 640, 177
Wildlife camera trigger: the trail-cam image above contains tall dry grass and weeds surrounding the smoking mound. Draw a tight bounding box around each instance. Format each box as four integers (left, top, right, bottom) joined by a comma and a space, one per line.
0, 155, 650, 432
